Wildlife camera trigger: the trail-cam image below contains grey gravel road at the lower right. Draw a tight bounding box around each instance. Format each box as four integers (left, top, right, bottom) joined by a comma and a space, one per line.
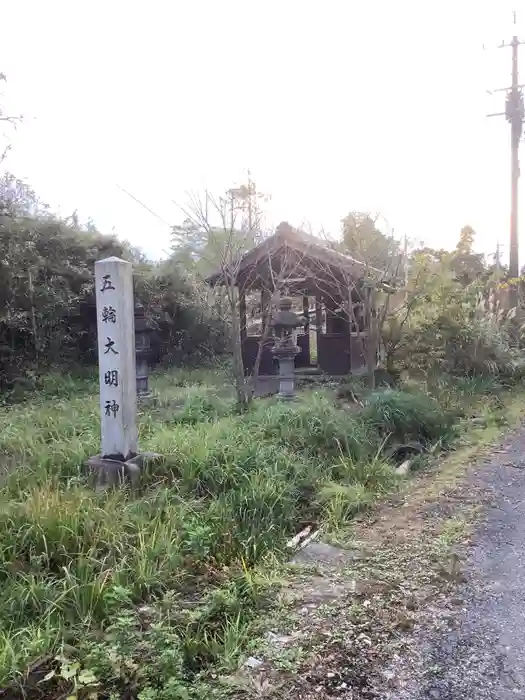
384, 427, 525, 700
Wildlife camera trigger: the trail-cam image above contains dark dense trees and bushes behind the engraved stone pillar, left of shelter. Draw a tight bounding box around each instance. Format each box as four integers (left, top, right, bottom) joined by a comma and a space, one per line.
0, 174, 227, 395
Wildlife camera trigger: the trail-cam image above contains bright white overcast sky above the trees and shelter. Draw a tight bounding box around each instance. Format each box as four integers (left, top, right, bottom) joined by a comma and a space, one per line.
0, 0, 525, 263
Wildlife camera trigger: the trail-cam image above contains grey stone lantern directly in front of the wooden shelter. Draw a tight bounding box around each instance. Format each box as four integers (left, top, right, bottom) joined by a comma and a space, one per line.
272, 297, 303, 400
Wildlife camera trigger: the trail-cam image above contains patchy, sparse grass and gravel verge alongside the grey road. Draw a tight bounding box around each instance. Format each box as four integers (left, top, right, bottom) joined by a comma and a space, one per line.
233, 389, 525, 700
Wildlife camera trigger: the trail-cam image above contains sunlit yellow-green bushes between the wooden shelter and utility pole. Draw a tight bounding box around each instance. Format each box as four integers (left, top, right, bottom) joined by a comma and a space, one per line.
384, 226, 524, 379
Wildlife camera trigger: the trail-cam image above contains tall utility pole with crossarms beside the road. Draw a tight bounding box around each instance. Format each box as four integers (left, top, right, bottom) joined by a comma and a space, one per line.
487, 12, 525, 310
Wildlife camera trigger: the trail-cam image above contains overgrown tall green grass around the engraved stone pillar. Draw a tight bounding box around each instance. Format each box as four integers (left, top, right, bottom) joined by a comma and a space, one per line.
0, 371, 511, 700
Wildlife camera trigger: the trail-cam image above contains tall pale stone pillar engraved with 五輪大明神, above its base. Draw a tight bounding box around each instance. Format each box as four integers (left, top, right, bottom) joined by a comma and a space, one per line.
95, 257, 138, 461
